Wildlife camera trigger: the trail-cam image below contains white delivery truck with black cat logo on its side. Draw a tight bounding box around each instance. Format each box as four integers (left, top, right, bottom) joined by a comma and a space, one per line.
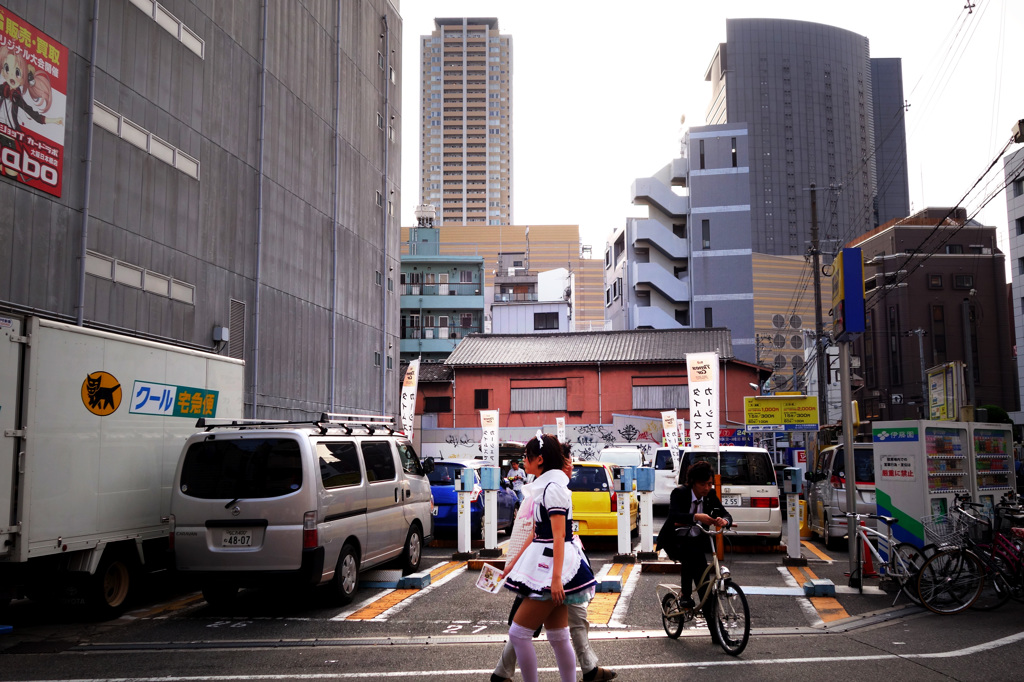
0, 315, 245, 616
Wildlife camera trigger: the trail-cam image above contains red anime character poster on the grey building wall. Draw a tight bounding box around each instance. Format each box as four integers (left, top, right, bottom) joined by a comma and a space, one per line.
0, 7, 70, 197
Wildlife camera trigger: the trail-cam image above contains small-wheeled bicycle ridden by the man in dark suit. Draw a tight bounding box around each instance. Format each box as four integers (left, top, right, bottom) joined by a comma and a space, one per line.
656, 524, 751, 656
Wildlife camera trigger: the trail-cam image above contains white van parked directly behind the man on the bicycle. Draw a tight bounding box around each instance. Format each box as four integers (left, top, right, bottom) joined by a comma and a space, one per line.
677, 445, 782, 545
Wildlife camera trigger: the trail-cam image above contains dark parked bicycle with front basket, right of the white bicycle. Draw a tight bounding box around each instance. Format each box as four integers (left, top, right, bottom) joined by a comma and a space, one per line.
918, 497, 985, 615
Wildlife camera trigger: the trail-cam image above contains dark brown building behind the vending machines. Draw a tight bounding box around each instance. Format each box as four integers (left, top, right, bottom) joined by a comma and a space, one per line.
847, 208, 1019, 420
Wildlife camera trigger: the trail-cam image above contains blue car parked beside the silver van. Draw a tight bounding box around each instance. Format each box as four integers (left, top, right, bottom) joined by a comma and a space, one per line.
427, 460, 519, 538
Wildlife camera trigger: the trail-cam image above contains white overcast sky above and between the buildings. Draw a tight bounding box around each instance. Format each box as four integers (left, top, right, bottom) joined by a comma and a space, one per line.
400, 0, 1024, 257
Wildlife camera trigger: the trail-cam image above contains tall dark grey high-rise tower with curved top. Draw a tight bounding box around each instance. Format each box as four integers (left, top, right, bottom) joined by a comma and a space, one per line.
705, 18, 909, 256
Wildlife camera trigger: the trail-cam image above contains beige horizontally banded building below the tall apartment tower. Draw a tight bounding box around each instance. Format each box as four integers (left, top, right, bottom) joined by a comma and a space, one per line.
401, 225, 604, 331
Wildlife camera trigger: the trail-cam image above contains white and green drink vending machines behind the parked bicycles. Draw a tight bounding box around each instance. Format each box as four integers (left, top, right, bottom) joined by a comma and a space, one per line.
871, 420, 1017, 547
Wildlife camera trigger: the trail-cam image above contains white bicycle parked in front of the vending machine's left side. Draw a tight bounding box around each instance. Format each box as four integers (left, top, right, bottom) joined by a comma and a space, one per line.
846, 512, 935, 605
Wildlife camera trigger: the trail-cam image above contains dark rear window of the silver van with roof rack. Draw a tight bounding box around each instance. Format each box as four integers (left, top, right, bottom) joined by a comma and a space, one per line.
180, 438, 302, 500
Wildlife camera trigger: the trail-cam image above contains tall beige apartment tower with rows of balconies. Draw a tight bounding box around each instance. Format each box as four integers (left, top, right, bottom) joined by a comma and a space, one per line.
420, 17, 512, 226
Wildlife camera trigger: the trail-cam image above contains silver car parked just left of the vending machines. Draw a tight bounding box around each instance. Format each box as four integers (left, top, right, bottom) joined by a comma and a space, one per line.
805, 442, 877, 549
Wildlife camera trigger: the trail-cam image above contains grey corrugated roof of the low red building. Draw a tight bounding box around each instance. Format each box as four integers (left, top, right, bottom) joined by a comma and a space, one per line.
444, 328, 732, 367
